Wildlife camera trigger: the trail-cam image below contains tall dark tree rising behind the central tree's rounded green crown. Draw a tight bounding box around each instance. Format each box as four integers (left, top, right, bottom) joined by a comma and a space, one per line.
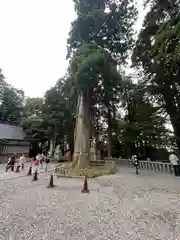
68, 0, 136, 156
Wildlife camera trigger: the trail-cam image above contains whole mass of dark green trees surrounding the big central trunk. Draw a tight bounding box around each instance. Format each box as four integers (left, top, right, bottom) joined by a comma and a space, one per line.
0, 0, 180, 160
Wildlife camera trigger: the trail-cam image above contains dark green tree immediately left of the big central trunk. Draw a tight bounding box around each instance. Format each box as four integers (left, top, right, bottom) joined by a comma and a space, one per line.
43, 81, 74, 150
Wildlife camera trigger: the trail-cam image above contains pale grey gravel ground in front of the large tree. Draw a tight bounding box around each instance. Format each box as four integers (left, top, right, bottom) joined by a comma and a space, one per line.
0, 165, 180, 240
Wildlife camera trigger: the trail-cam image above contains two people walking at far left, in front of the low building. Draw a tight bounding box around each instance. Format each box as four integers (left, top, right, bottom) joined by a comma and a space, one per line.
6, 153, 26, 172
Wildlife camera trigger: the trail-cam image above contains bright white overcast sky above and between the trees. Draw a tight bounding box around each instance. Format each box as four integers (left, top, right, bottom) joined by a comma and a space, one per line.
0, 0, 144, 97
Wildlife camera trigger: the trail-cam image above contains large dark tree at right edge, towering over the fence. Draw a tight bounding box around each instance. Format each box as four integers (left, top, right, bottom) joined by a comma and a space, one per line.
133, 0, 180, 150
